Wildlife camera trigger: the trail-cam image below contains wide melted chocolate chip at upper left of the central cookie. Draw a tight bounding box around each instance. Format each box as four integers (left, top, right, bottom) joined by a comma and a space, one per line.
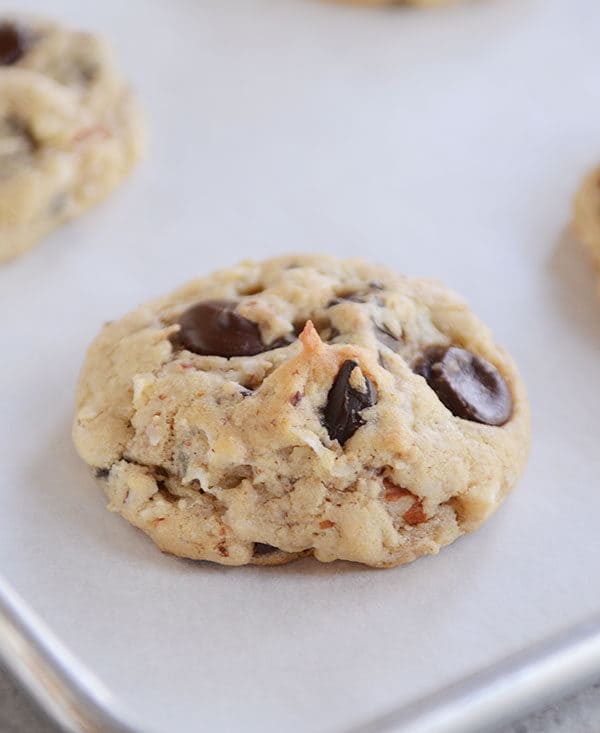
175, 300, 292, 358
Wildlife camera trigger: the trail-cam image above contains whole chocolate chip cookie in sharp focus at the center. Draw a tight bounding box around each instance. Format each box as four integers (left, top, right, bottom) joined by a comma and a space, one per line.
73, 255, 529, 567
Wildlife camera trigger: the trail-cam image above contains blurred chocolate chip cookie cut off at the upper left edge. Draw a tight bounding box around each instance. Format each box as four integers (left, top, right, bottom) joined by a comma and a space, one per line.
0, 19, 143, 261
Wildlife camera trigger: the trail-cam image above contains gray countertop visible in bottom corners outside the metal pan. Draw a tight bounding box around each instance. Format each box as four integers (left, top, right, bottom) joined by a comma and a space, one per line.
0, 668, 600, 733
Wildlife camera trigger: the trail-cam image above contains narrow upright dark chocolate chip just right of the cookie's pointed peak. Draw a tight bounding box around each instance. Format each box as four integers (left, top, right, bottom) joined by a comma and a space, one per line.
323, 359, 377, 445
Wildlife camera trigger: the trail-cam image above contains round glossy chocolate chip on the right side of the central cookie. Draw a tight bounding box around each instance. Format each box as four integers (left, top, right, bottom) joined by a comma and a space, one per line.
414, 346, 513, 425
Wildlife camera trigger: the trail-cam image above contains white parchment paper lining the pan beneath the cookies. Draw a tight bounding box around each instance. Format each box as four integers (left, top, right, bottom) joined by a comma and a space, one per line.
0, 0, 600, 733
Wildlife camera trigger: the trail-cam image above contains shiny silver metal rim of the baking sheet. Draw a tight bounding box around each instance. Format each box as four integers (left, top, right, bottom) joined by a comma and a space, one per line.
0, 575, 600, 733
